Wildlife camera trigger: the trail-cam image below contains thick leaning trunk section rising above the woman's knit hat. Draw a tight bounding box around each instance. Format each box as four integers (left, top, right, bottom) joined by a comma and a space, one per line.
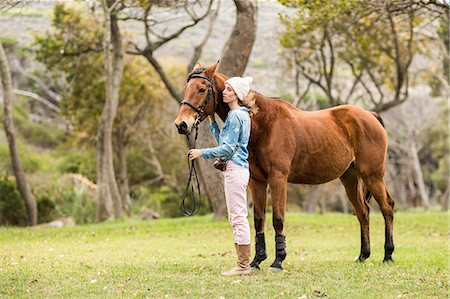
218, 0, 258, 77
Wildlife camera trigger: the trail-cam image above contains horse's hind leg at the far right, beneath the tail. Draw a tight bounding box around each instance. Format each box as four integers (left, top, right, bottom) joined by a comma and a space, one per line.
363, 176, 394, 263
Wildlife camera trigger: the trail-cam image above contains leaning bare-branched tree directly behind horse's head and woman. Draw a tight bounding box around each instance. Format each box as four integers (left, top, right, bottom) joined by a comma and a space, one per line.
128, 0, 256, 217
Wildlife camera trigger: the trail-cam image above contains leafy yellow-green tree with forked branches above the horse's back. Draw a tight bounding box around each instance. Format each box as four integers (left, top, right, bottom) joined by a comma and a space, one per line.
280, 0, 444, 112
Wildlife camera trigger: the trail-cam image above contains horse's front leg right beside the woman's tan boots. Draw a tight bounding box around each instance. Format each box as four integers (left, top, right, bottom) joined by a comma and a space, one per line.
249, 178, 267, 269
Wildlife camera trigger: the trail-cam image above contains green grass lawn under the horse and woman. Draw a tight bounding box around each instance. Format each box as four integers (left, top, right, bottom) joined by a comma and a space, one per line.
0, 212, 449, 298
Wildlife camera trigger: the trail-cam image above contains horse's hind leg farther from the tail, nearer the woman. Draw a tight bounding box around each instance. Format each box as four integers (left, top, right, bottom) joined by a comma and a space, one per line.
340, 165, 370, 262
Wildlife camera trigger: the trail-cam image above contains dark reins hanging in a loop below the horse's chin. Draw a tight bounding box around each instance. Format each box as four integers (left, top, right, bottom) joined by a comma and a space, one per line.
181, 120, 201, 216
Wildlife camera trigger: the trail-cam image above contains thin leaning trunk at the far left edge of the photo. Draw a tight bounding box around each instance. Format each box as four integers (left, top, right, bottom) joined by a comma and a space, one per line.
0, 43, 37, 226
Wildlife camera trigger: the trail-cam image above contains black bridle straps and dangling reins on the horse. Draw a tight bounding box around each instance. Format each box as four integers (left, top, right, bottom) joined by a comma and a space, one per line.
181, 73, 217, 216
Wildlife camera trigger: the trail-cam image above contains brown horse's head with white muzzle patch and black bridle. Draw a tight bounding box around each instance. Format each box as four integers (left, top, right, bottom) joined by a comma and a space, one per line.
175, 63, 217, 135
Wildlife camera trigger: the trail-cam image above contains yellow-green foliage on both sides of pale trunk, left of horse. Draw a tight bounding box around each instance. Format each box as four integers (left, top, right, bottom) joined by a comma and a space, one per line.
35, 4, 185, 184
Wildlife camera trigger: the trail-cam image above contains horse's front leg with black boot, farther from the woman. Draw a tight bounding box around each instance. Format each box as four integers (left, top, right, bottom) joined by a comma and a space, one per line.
269, 172, 287, 271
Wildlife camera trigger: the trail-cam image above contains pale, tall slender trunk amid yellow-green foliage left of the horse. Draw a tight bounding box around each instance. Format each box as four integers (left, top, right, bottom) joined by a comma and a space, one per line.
97, 0, 123, 221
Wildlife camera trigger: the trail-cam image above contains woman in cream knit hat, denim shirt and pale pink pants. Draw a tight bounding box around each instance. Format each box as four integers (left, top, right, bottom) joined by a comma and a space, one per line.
189, 77, 253, 276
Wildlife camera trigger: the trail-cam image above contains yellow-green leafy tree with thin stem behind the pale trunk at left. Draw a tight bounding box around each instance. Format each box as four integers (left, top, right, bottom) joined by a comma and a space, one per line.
35, 4, 178, 218
